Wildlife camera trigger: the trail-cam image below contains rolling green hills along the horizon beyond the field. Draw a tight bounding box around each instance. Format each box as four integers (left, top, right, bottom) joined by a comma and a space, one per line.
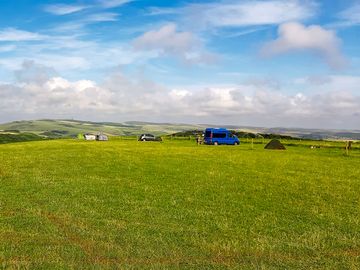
0, 119, 360, 140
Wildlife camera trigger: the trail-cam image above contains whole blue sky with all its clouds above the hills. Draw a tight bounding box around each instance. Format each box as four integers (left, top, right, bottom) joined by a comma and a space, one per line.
0, 0, 360, 129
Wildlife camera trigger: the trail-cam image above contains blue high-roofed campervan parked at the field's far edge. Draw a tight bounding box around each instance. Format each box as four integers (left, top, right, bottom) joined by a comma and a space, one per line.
204, 128, 240, 145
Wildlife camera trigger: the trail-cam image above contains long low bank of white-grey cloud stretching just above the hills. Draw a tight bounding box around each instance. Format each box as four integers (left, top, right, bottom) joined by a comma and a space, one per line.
0, 62, 360, 127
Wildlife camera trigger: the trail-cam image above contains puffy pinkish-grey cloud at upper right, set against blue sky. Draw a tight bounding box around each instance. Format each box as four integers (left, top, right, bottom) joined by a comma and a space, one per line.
262, 22, 346, 68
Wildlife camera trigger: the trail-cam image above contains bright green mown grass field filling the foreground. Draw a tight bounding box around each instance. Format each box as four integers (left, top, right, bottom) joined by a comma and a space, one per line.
0, 140, 360, 269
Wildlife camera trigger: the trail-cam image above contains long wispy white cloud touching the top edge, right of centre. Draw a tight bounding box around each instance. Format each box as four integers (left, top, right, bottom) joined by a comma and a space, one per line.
147, 0, 318, 29
